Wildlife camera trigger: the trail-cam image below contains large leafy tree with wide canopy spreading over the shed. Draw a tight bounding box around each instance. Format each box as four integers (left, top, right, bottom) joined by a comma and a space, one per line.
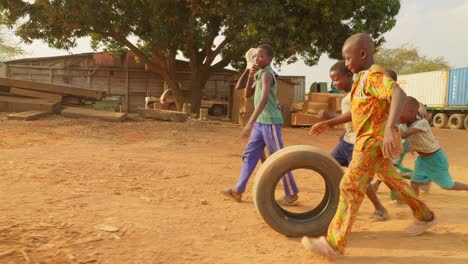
0, 0, 400, 111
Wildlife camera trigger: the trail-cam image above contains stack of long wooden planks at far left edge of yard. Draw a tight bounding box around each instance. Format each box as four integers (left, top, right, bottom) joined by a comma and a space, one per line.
0, 78, 126, 121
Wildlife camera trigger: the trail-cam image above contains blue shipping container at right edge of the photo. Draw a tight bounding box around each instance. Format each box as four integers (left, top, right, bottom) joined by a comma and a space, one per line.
447, 68, 468, 106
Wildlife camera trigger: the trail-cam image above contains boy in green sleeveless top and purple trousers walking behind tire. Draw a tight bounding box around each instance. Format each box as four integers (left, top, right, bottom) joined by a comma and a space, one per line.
222, 44, 298, 205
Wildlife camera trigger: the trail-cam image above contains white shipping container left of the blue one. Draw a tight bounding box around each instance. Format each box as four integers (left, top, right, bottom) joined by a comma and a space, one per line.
398, 70, 448, 107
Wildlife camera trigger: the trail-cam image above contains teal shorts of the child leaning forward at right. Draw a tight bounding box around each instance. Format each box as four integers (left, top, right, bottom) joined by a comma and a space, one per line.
411, 149, 455, 189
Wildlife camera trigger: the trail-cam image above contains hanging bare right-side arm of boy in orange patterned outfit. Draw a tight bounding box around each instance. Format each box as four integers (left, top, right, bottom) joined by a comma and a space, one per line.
383, 85, 406, 158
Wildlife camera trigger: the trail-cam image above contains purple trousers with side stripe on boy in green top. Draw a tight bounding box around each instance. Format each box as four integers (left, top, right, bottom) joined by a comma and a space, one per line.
236, 123, 299, 195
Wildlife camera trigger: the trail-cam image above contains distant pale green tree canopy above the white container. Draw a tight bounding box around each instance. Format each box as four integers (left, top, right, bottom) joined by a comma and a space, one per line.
375, 44, 450, 74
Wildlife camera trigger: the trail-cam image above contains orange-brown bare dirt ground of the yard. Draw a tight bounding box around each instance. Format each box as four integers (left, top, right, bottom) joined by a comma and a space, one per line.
0, 115, 468, 264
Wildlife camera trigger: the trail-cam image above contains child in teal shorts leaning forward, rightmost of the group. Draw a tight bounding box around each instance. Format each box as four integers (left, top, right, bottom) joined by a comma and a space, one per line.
400, 96, 468, 195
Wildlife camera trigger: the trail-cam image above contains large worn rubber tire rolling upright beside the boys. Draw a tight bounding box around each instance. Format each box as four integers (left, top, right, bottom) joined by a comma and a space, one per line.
253, 145, 344, 237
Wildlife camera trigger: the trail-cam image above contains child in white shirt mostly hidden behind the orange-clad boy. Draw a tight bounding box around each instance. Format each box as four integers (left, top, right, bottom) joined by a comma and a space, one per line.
311, 61, 388, 221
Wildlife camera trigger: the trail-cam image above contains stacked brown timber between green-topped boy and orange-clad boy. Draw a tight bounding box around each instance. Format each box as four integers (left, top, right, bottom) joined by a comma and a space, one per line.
291, 93, 344, 126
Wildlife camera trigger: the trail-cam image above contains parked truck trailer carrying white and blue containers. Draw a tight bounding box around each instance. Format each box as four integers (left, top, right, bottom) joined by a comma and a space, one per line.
398, 68, 468, 129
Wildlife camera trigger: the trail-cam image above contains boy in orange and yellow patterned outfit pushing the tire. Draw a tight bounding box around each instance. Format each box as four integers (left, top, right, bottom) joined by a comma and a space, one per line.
302, 33, 437, 256
